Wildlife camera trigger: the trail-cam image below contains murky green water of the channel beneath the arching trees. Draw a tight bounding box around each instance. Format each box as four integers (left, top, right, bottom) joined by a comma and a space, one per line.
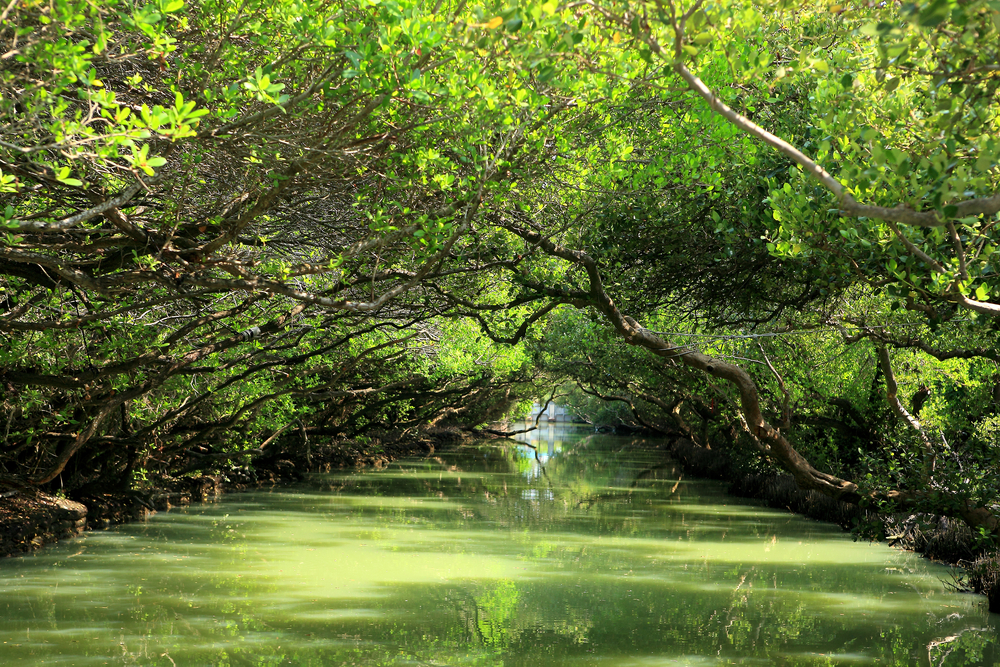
0, 427, 1000, 667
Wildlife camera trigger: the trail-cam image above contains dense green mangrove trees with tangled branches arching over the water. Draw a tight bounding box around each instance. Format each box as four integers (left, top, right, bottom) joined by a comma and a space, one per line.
0, 0, 1000, 552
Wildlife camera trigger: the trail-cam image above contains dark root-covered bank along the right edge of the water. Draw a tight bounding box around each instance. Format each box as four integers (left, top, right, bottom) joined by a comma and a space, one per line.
670, 438, 1000, 612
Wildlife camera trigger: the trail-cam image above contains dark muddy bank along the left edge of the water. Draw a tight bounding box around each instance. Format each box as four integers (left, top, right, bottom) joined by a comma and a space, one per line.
0, 428, 471, 557
